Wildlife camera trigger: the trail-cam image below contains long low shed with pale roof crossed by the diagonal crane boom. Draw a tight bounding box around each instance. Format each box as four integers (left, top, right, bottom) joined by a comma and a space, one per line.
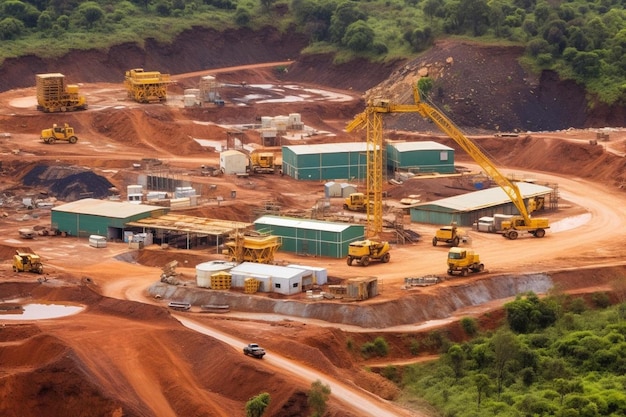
410, 182, 553, 227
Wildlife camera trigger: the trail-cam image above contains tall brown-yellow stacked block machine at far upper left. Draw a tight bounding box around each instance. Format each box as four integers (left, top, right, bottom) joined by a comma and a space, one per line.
35, 73, 87, 113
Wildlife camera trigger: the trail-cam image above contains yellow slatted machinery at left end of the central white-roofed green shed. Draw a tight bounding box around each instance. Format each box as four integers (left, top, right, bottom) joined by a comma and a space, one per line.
224, 232, 280, 264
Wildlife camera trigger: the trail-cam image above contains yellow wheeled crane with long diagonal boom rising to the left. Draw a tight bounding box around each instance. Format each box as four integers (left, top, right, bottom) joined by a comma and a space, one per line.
412, 85, 550, 239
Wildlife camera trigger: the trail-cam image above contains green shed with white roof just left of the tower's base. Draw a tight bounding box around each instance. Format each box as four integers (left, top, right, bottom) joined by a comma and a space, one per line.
254, 216, 365, 258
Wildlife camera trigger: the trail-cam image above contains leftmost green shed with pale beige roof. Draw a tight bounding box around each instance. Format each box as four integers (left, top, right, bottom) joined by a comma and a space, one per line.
51, 198, 168, 241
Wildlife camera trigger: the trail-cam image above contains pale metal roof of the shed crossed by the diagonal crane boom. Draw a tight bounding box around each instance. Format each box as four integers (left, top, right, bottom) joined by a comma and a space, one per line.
416, 182, 552, 211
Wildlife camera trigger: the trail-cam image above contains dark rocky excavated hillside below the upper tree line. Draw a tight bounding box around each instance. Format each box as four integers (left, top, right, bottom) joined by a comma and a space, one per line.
0, 28, 626, 132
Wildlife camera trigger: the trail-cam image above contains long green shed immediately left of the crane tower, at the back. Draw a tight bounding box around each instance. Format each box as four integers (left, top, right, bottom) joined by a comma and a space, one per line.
283, 142, 367, 181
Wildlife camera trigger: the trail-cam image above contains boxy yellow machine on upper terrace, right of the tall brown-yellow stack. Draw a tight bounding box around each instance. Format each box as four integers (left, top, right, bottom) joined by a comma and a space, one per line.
124, 68, 172, 103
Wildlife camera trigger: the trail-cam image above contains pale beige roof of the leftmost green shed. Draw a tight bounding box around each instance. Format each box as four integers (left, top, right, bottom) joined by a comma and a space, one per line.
52, 198, 163, 219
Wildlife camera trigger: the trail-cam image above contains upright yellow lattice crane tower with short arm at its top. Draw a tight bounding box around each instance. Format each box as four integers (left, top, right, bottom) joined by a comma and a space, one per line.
346, 95, 422, 237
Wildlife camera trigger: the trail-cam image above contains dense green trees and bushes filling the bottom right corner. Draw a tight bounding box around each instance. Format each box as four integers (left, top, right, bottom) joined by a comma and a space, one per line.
398, 293, 626, 417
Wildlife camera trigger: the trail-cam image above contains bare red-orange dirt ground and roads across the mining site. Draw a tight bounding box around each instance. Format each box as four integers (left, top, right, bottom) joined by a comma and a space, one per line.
0, 35, 626, 417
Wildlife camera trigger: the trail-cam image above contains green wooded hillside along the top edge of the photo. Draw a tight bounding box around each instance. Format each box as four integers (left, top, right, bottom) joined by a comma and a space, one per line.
0, 0, 626, 105
